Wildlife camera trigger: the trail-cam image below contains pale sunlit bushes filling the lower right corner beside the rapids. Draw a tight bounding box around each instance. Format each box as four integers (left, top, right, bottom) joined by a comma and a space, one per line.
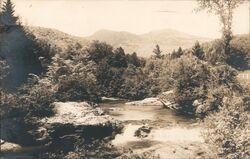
204, 95, 250, 159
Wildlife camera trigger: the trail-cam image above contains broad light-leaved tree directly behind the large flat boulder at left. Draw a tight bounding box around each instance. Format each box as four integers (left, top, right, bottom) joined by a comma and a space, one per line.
46, 44, 99, 101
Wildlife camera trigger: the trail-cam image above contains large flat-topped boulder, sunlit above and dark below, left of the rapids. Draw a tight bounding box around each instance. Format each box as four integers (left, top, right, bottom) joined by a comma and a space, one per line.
33, 102, 122, 151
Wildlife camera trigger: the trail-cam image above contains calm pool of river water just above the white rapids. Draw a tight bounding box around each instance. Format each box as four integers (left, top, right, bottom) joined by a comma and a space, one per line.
101, 102, 196, 126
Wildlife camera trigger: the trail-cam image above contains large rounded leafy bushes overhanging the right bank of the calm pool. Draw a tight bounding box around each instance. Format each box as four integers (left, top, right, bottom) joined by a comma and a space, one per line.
161, 52, 243, 117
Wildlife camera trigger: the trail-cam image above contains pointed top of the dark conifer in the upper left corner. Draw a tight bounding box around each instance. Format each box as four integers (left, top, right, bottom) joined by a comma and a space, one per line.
0, 0, 18, 26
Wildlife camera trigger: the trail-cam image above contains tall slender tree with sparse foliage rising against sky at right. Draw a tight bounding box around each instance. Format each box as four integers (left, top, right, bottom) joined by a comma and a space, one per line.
198, 0, 244, 53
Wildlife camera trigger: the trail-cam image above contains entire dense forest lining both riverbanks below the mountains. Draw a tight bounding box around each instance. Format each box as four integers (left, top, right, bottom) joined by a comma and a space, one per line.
0, 0, 250, 158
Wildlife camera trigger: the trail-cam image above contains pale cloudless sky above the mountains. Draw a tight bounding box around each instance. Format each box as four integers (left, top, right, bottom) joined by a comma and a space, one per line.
10, 0, 250, 38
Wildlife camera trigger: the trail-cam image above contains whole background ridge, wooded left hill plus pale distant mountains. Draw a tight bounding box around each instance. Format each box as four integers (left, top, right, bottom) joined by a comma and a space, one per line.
28, 27, 211, 57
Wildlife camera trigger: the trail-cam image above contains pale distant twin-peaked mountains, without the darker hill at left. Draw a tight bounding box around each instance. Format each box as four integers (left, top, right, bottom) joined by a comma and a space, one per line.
85, 29, 212, 57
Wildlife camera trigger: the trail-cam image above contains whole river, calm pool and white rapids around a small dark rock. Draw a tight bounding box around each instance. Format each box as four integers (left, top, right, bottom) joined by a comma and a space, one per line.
101, 101, 207, 158
